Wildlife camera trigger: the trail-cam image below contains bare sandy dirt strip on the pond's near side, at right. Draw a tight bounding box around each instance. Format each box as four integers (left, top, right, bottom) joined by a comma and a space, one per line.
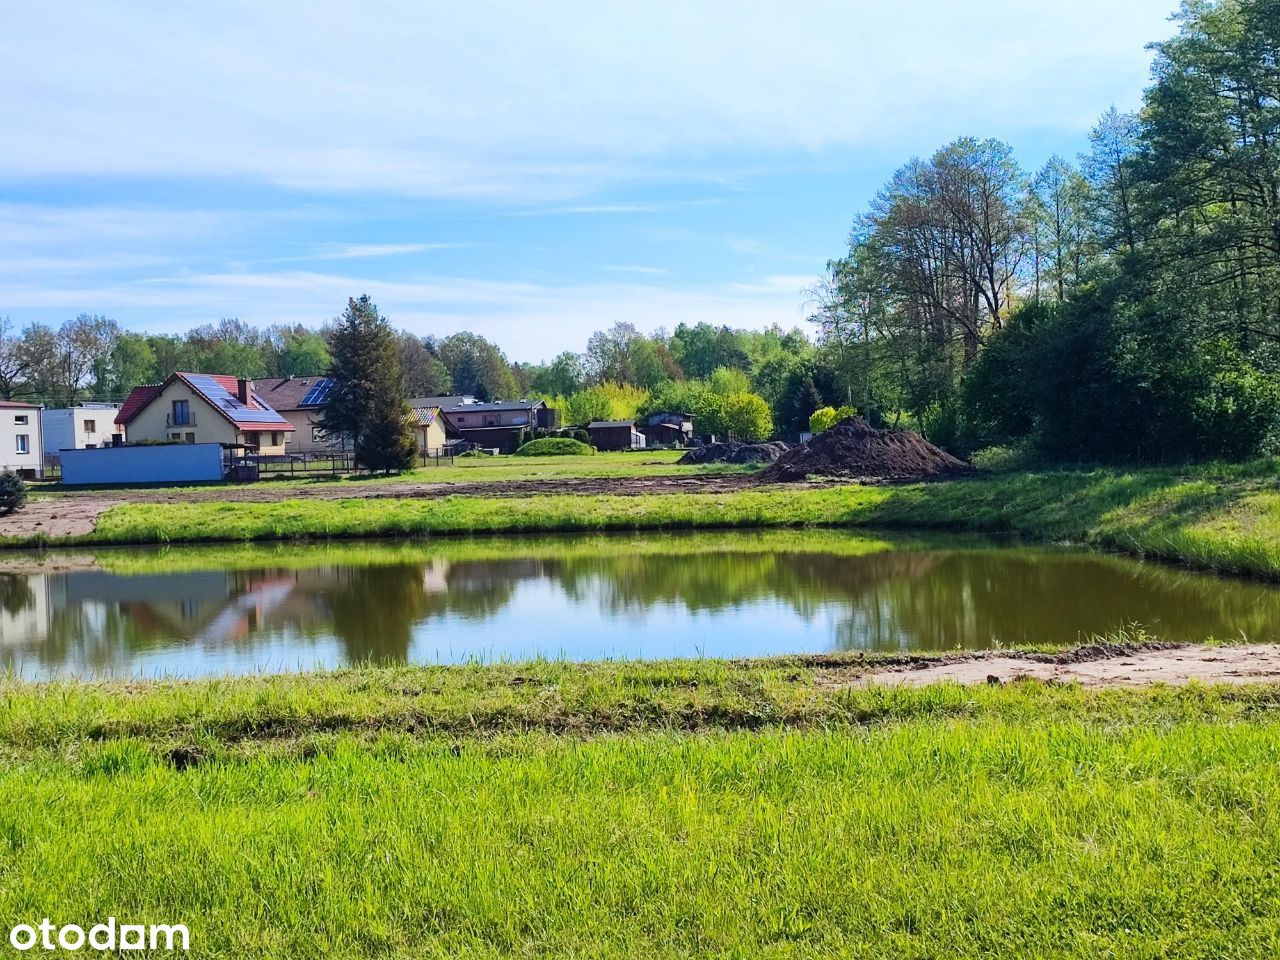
841, 644, 1280, 687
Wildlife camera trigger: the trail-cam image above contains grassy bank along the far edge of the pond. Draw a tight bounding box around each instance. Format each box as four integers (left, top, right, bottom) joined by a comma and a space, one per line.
57, 461, 1280, 579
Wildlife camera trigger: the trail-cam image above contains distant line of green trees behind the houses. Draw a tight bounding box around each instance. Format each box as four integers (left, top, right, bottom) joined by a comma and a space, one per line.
0, 312, 833, 439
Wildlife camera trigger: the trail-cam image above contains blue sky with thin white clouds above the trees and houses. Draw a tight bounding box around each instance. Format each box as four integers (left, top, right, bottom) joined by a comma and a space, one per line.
0, 0, 1172, 361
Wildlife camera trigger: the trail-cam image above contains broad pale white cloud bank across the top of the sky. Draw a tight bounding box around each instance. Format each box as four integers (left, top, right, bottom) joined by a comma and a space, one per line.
0, 0, 1172, 197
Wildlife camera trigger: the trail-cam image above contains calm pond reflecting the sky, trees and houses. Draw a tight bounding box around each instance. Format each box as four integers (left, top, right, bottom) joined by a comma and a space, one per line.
0, 531, 1280, 678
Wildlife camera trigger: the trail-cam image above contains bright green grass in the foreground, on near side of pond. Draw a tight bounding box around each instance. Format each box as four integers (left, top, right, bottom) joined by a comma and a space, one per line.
0, 660, 1280, 957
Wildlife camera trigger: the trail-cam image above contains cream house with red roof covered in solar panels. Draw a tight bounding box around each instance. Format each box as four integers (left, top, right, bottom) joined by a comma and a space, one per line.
115, 372, 296, 454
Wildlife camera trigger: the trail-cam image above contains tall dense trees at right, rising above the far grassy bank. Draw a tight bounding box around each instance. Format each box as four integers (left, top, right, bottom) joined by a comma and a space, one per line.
813, 0, 1280, 461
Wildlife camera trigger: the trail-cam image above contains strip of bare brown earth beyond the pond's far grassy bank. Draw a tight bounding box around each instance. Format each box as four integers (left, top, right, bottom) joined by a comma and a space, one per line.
0, 474, 768, 536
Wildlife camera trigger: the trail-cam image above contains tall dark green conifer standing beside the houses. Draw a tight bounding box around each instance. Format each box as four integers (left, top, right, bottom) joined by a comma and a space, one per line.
321, 293, 416, 472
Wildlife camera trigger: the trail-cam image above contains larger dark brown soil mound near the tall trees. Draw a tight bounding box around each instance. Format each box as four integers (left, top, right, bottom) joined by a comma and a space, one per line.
759, 417, 972, 483
